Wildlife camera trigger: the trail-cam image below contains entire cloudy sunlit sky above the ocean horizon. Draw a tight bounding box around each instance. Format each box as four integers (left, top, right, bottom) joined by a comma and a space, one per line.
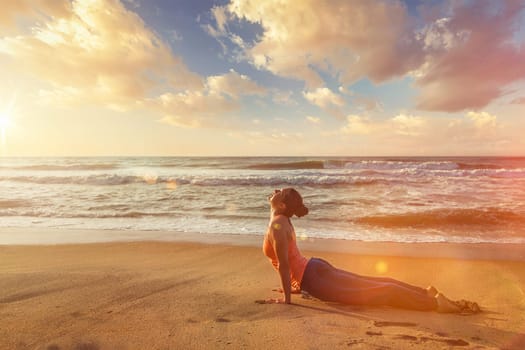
0, 0, 525, 156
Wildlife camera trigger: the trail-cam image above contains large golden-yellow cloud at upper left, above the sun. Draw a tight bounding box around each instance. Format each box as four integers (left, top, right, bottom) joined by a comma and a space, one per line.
0, 0, 266, 127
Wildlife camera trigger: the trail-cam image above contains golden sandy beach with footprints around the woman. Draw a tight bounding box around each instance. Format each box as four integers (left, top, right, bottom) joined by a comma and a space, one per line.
0, 230, 525, 350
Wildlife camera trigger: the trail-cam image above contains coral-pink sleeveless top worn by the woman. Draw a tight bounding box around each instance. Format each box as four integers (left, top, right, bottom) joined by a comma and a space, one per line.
263, 219, 308, 290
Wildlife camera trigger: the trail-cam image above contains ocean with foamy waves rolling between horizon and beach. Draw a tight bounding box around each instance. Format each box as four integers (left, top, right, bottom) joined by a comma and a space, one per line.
0, 157, 525, 243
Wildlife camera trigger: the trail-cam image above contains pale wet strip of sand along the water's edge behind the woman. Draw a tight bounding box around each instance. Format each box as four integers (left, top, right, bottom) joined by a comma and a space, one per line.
0, 228, 525, 261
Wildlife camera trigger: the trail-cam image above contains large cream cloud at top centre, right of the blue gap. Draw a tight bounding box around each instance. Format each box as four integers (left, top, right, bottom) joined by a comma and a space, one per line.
210, 0, 422, 89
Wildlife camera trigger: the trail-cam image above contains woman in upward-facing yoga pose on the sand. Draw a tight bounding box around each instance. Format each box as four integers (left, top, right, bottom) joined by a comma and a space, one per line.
263, 188, 480, 312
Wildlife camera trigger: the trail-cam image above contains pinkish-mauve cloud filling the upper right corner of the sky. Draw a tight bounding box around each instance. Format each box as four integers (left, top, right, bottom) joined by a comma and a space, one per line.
416, 1, 525, 112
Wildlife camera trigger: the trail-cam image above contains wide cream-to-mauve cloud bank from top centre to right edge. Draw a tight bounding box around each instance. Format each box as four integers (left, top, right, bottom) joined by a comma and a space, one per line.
210, 0, 525, 112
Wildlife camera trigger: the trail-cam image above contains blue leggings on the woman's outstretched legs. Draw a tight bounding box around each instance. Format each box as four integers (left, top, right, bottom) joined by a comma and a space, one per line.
301, 258, 437, 311
